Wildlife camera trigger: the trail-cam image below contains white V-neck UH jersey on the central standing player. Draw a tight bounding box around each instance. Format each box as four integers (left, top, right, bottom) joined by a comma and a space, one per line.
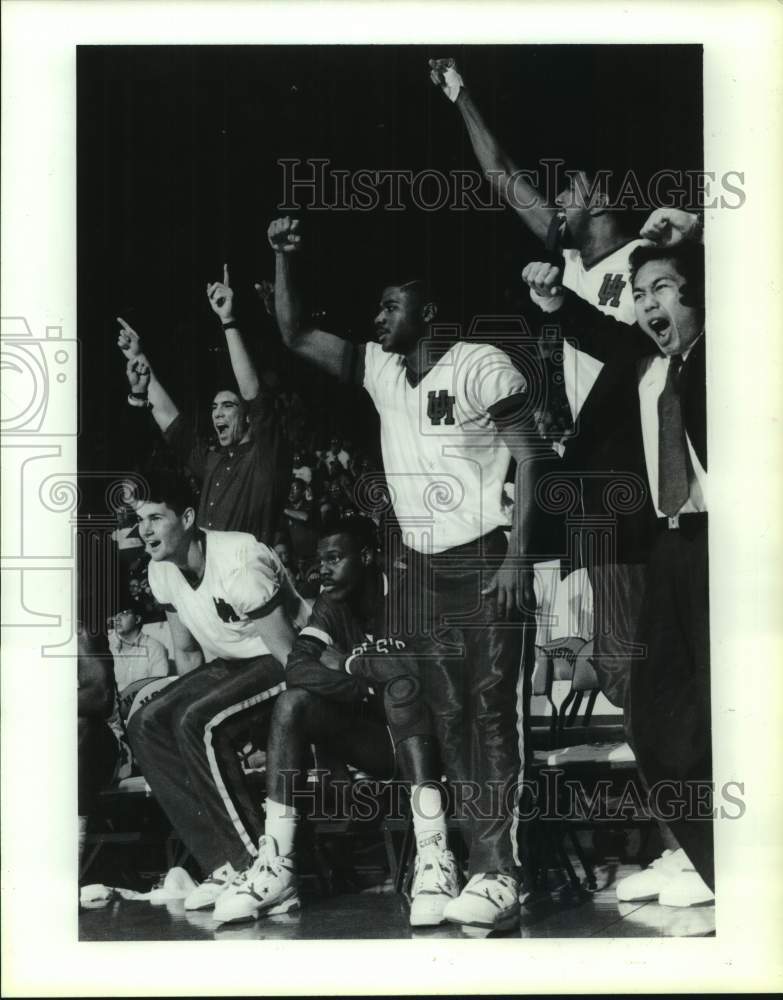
364, 341, 526, 553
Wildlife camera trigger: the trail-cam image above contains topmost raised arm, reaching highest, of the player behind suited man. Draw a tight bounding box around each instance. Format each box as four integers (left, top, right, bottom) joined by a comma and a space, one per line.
430, 59, 555, 240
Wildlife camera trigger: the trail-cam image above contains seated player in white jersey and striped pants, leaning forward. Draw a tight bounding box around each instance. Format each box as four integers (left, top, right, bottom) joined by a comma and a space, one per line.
128, 477, 307, 909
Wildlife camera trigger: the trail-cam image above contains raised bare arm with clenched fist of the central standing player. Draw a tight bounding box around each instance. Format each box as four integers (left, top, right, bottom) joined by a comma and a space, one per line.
267, 217, 355, 382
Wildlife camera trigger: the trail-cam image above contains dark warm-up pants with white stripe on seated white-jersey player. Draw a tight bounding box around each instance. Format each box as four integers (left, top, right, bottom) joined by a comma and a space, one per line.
128, 656, 285, 874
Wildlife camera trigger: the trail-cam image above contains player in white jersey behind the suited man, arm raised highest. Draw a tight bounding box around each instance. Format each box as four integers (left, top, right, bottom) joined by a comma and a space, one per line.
430, 59, 648, 720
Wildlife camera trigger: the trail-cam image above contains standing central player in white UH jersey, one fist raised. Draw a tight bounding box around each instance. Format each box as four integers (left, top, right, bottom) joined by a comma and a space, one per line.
269, 218, 535, 930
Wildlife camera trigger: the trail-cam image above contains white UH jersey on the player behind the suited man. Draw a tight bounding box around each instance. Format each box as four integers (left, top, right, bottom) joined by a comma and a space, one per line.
563, 240, 643, 419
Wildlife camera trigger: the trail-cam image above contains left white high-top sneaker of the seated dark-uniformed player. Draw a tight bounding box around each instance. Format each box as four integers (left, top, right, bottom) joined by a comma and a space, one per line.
214, 836, 299, 923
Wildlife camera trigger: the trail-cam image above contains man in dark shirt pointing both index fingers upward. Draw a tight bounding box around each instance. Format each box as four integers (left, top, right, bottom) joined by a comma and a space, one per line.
117, 266, 291, 545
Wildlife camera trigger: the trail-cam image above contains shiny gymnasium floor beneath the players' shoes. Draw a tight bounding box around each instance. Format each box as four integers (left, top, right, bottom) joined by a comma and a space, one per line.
79, 865, 715, 941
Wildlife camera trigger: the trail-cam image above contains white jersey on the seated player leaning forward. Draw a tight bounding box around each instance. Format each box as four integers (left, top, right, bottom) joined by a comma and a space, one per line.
147, 531, 309, 660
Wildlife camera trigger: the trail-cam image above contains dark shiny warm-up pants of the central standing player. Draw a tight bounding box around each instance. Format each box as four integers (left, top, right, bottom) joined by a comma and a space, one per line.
392, 530, 535, 875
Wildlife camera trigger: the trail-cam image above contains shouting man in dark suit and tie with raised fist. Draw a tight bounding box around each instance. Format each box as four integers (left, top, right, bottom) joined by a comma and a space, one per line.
523, 241, 714, 888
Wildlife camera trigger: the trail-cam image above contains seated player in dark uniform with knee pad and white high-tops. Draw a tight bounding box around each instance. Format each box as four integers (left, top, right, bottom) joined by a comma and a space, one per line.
215, 516, 459, 927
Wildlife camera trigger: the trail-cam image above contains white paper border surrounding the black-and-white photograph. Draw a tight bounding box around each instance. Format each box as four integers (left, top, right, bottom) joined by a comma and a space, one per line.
0, 0, 783, 996
